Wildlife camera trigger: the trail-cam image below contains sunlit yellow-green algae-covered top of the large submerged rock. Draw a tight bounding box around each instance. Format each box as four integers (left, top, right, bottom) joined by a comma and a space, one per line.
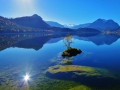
46, 65, 115, 78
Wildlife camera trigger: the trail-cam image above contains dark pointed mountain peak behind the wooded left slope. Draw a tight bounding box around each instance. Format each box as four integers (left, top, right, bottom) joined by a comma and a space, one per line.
10, 14, 51, 29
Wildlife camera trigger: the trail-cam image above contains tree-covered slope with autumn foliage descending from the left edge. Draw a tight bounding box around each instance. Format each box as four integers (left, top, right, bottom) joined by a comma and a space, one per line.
0, 16, 53, 33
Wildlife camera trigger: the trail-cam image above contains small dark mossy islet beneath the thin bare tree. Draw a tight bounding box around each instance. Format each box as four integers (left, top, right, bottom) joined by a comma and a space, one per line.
62, 47, 82, 58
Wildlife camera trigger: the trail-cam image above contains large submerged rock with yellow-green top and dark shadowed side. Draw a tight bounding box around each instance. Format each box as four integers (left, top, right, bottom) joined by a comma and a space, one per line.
46, 65, 116, 87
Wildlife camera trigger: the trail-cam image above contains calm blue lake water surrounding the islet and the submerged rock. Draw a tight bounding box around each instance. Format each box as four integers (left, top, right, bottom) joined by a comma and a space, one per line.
0, 33, 120, 90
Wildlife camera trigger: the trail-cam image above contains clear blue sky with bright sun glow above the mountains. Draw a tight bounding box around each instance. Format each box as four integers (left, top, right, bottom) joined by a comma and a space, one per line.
0, 0, 120, 24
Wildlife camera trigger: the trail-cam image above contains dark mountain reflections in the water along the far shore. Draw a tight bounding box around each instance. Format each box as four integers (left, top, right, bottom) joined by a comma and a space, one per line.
0, 33, 120, 51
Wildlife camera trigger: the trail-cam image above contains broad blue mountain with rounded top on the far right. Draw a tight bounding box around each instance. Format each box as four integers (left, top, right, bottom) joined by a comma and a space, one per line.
88, 19, 119, 30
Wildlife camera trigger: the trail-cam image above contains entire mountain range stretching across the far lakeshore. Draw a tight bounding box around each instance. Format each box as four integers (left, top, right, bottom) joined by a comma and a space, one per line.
0, 14, 120, 34
